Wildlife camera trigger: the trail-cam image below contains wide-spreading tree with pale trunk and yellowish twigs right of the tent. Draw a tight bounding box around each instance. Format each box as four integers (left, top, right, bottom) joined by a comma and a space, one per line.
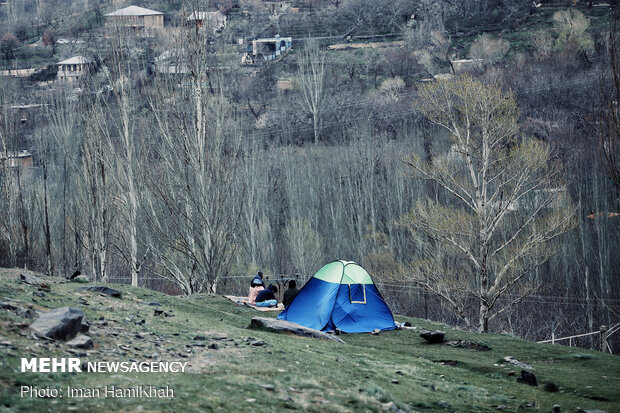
403, 76, 573, 332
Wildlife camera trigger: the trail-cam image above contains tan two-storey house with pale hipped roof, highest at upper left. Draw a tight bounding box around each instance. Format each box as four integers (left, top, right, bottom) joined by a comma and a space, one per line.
104, 6, 164, 37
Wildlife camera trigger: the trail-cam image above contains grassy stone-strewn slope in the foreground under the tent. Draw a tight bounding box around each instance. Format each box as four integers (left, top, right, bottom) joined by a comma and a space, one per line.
0, 269, 620, 412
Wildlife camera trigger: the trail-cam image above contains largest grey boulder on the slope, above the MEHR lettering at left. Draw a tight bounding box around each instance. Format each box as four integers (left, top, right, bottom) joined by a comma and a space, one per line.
30, 307, 84, 340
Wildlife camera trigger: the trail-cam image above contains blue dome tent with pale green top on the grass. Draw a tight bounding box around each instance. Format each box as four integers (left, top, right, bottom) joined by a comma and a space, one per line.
278, 260, 396, 333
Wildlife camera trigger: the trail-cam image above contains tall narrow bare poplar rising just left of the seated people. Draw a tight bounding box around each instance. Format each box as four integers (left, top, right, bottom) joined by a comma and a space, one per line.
147, 15, 244, 294
